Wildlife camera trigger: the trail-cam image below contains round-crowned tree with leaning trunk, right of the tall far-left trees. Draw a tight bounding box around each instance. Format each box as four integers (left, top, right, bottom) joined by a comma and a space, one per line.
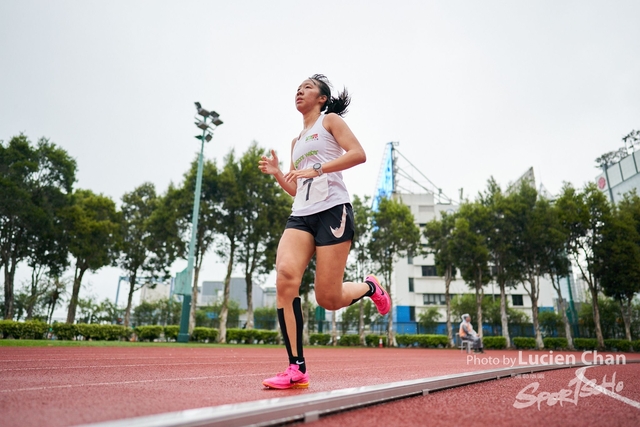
63, 190, 122, 323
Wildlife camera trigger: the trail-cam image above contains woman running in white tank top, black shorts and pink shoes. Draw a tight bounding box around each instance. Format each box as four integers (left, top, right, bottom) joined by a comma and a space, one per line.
259, 74, 391, 389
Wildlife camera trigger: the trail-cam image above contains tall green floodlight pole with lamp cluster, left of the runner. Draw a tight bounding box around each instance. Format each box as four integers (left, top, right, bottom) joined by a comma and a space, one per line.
177, 103, 222, 342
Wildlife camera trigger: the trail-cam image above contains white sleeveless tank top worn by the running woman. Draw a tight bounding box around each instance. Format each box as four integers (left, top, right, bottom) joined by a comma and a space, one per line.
291, 114, 351, 216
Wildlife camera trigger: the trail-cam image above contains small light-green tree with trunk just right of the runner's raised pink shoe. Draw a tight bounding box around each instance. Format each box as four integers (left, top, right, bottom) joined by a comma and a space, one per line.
369, 198, 420, 346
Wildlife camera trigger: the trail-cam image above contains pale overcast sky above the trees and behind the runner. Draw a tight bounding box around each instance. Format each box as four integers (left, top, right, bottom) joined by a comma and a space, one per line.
0, 0, 640, 310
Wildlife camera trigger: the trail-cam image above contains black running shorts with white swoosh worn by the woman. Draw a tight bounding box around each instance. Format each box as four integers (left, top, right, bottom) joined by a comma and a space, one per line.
285, 203, 355, 246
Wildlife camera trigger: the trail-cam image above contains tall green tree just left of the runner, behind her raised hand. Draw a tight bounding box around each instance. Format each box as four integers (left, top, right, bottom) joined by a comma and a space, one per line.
237, 141, 291, 329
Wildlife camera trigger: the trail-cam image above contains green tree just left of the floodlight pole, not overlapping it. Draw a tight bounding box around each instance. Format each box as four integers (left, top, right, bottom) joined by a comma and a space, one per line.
118, 183, 175, 326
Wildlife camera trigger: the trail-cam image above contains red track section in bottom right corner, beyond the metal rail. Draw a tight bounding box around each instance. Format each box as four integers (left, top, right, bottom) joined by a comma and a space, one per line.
306, 363, 640, 427
